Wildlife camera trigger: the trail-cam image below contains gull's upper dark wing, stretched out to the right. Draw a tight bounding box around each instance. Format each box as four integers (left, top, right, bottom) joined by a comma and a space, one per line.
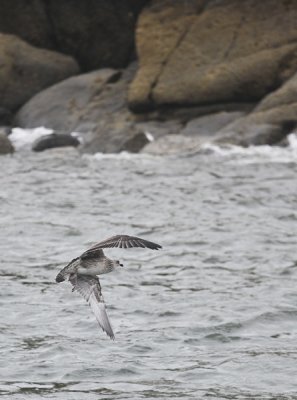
84, 235, 162, 254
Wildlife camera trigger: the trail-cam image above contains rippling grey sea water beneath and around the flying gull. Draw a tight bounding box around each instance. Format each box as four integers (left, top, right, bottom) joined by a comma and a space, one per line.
0, 138, 297, 400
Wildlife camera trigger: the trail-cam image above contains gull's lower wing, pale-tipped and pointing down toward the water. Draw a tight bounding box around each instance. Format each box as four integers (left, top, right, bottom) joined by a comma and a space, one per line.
69, 275, 114, 339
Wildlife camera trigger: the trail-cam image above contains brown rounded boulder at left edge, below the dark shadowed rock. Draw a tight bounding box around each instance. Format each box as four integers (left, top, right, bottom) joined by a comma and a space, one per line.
0, 34, 79, 110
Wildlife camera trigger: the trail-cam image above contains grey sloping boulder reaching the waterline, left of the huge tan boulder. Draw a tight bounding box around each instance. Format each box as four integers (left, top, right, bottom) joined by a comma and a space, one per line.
14, 66, 145, 153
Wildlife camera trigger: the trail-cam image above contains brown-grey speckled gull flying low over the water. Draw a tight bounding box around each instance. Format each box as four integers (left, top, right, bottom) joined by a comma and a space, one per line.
56, 235, 162, 339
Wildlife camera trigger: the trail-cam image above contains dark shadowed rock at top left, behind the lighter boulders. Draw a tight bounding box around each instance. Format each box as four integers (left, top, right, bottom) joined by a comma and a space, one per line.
0, 0, 148, 71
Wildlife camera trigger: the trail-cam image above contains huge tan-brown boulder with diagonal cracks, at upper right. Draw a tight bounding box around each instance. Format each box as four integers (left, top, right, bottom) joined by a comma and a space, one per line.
129, 0, 297, 111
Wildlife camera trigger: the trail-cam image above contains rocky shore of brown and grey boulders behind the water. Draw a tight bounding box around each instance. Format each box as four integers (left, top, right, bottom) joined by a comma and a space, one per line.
0, 0, 297, 153
